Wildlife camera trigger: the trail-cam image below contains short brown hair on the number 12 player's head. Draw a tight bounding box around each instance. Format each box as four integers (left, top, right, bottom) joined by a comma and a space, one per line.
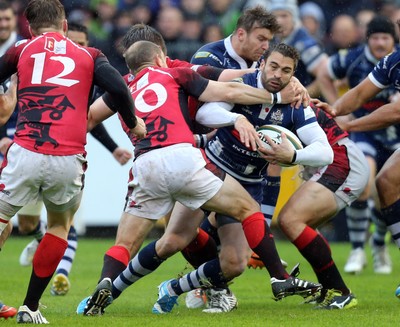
25, 0, 65, 31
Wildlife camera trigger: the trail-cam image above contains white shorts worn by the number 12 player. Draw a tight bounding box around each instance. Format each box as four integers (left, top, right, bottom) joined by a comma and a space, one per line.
0, 143, 87, 207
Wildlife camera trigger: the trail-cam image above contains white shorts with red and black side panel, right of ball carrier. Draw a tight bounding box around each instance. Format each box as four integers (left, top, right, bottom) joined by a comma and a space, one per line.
303, 138, 369, 210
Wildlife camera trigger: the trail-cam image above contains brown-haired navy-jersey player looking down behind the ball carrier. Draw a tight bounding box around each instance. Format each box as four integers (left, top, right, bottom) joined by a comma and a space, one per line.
190, 6, 288, 274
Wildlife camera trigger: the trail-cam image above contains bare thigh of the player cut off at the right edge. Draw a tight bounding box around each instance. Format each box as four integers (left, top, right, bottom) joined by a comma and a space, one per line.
376, 150, 400, 207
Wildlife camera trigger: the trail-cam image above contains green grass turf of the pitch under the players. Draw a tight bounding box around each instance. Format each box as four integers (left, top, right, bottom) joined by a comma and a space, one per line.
0, 237, 400, 327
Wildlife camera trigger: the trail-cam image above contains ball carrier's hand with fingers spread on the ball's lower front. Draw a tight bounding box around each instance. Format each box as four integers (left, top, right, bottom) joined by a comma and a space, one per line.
258, 133, 294, 165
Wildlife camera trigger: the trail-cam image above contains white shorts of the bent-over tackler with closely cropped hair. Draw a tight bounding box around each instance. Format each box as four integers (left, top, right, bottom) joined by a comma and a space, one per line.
125, 143, 223, 220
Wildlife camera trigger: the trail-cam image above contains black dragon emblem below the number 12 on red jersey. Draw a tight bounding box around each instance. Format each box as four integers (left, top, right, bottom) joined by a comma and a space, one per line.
16, 86, 75, 149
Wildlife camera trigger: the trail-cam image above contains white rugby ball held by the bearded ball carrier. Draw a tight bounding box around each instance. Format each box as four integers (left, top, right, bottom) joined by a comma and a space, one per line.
257, 125, 303, 167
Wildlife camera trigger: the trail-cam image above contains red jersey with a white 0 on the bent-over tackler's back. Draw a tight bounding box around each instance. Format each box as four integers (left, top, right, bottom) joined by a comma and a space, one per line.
123, 67, 208, 156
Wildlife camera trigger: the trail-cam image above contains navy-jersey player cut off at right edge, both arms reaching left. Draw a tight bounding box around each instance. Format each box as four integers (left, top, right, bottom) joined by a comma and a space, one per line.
313, 18, 400, 295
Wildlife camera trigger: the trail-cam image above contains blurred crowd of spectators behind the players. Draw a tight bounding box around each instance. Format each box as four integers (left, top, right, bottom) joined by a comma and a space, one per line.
7, 0, 400, 74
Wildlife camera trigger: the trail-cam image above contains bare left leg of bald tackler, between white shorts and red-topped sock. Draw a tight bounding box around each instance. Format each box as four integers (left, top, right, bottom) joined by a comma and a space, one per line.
115, 212, 157, 255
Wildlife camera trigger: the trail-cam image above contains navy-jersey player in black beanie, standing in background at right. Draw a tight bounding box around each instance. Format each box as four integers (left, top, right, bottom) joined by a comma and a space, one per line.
318, 16, 400, 274
